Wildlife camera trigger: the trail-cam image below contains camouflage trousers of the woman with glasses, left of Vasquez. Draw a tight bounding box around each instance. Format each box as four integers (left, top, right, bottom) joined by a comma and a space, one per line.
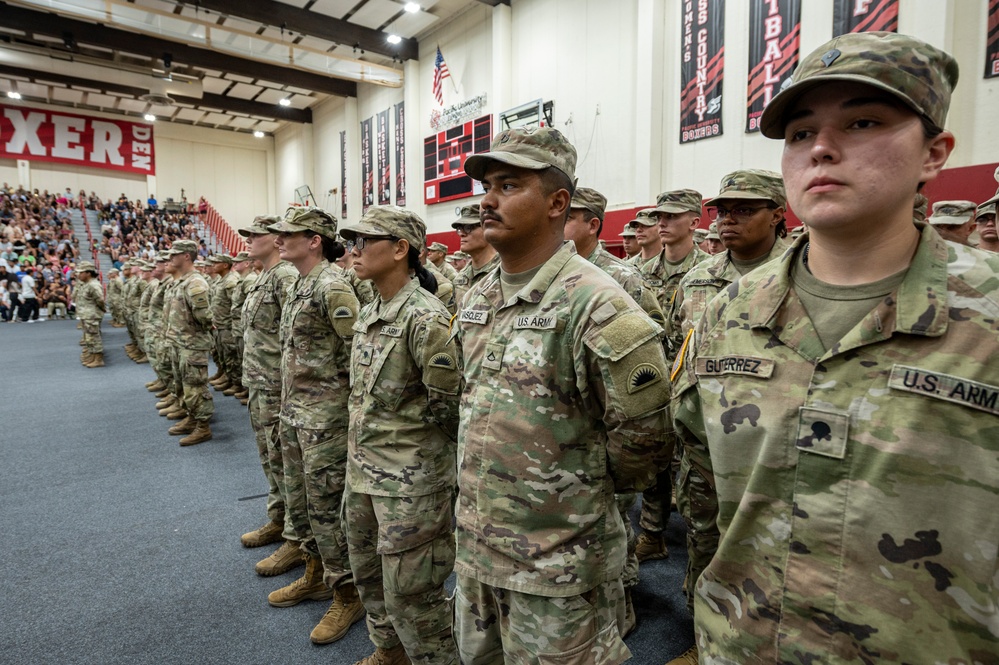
344, 488, 458, 665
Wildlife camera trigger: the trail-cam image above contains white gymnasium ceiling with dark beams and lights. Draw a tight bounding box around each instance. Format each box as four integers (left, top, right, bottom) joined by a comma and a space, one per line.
0, 0, 509, 134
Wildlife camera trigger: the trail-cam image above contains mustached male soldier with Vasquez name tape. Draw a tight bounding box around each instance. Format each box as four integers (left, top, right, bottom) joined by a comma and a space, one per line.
453, 127, 669, 665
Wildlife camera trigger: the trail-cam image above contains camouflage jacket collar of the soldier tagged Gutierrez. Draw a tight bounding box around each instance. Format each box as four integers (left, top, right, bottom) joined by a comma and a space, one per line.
749, 222, 949, 337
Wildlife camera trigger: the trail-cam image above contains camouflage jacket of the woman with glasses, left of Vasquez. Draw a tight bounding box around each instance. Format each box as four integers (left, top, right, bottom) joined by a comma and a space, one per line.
347, 279, 461, 498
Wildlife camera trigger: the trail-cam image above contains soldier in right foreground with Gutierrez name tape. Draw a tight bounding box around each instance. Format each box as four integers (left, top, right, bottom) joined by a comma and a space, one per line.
672, 33, 999, 663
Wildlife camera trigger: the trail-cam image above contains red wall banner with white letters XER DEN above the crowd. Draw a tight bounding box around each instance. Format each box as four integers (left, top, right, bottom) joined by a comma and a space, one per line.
0, 104, 156, 175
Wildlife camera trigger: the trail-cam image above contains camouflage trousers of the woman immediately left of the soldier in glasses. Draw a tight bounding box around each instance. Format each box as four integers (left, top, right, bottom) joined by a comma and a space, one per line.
281, 422, 351, 587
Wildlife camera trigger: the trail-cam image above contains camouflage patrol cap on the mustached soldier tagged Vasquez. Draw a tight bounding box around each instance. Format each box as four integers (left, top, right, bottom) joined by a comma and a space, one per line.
465, 127, 576, 184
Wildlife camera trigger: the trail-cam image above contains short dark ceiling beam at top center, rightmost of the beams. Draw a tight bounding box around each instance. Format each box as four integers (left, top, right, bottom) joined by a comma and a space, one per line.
184, 0, 420, 60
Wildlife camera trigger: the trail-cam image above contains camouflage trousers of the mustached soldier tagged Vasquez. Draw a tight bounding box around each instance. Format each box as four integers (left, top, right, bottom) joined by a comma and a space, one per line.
454, 574, 631, 665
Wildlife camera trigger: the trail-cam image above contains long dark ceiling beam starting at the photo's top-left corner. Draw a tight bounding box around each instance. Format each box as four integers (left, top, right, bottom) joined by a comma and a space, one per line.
0, 2, 357, 97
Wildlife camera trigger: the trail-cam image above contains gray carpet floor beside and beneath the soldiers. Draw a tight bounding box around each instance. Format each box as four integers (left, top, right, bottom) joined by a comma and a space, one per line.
0, 320, 692, 665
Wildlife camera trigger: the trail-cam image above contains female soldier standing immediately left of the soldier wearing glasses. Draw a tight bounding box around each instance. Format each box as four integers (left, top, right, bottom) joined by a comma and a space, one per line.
267, 207, 364, 644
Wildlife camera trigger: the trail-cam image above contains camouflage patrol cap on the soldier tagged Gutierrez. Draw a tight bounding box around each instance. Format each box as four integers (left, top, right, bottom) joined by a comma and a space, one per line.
760, 32, 958, 139
